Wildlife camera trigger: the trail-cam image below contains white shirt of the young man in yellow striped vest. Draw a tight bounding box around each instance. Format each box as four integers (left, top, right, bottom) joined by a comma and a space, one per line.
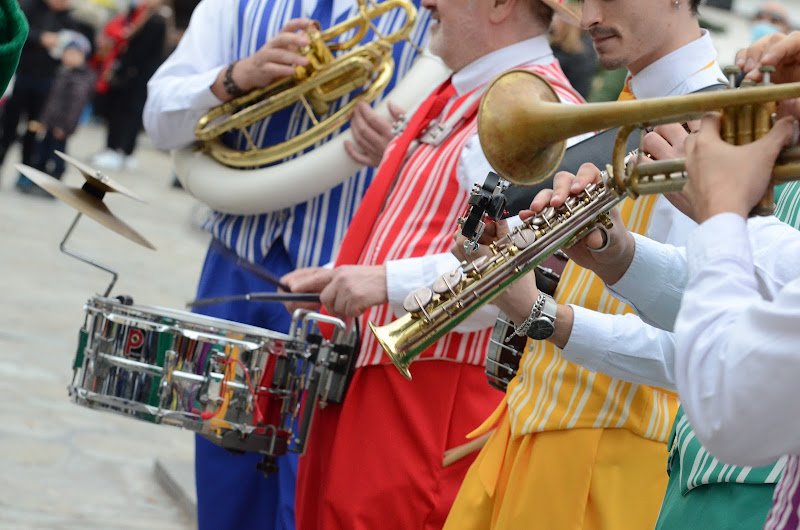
561, 30, 724, 376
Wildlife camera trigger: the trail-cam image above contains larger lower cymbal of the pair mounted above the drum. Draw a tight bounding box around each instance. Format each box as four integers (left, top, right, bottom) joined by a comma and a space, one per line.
14, 164, 156, 250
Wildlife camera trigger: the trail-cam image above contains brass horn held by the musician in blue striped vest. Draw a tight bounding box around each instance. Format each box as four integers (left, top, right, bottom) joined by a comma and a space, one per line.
195, 0, 417, 168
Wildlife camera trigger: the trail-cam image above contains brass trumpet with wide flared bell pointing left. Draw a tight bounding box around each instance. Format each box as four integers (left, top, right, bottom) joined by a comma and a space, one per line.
478, 69, 800, 186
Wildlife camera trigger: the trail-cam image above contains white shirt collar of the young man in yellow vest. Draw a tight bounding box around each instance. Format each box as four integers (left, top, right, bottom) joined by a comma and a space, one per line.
628, 30, 725, 99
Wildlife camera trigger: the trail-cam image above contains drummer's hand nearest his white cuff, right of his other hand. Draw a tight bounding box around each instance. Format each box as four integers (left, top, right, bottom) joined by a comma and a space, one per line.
320, 265, 389, 318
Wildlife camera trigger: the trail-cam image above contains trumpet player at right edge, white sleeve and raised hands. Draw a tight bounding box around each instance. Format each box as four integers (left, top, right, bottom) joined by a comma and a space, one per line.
675, 32, 800, 530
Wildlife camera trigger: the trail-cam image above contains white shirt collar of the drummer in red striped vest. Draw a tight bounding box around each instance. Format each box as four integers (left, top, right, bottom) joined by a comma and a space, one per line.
452, 35, 555, 96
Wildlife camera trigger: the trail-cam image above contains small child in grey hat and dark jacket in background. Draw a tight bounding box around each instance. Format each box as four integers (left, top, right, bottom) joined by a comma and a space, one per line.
21, 32, 95, 197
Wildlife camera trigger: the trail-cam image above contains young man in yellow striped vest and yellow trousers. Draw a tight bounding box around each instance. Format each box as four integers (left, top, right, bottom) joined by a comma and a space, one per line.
447, 0, 732, 529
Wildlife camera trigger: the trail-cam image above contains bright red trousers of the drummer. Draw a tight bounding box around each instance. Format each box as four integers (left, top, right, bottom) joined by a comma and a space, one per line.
296, 361, 503, 530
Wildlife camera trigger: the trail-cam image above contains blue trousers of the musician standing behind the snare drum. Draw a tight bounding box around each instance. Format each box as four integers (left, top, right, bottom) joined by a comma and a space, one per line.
195, 241, 298, 530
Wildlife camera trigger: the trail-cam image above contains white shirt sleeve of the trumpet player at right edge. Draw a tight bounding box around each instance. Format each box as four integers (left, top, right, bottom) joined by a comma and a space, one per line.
675, 214, 800, 466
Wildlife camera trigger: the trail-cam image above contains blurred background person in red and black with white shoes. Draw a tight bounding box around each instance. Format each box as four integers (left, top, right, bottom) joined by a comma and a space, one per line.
91, 0, 167, 171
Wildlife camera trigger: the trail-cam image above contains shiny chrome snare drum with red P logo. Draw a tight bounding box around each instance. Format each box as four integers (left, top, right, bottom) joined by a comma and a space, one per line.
69, 297, 315, 456
